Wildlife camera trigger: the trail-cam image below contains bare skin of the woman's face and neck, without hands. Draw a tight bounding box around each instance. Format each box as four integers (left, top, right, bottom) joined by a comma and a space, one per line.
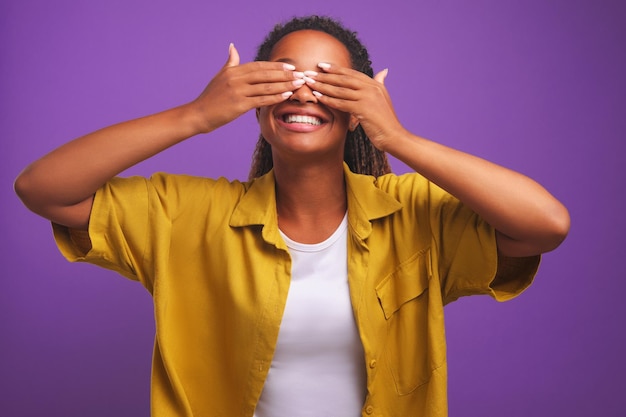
258, 30, 352, 243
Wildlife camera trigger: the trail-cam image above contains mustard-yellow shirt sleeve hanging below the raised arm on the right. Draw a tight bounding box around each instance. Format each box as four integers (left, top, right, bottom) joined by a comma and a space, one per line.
429, 177, 540, 303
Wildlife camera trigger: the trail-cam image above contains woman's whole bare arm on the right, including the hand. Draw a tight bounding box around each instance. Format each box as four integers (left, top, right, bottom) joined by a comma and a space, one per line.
310, 66, 570, 257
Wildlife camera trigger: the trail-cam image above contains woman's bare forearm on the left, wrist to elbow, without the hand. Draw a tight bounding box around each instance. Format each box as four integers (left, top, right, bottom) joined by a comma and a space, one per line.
15, 105, 200, 218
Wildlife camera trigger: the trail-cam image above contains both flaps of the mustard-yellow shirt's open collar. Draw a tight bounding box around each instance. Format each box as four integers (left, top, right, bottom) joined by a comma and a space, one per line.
230, 163, 402, 240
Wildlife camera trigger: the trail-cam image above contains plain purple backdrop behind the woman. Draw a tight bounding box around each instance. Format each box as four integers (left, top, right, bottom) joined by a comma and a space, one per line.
0, 0, 626, 416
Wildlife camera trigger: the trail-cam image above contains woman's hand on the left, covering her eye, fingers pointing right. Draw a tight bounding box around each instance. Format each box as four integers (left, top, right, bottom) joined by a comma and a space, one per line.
190, 44, 304, 133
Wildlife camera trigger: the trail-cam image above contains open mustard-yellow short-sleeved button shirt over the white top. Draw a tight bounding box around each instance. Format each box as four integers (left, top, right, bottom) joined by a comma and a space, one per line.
54, 167, 539, 417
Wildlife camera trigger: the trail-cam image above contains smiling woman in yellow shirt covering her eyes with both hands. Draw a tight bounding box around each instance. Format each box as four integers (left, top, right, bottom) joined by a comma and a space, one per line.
15, 16, 569, 417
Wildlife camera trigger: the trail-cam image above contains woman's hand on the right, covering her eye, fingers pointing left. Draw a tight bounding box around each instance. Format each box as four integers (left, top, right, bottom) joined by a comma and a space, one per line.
305, 63, 405, 151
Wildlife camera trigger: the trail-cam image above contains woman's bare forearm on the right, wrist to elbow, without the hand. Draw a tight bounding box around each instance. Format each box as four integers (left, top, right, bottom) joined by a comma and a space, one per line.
386, 132, 569, 256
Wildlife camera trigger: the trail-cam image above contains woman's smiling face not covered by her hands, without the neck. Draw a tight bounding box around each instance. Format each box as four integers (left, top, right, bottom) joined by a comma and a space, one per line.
258, 30, 356, 176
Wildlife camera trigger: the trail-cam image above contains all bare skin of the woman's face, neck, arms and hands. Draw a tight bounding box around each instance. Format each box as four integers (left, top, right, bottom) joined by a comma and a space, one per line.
15, 30, 570, 257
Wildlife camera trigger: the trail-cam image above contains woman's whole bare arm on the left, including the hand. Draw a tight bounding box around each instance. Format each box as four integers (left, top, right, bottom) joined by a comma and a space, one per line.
15, 45, 304, 230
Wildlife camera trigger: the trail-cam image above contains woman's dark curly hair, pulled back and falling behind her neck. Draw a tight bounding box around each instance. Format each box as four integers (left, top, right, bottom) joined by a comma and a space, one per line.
249, 16, 391, 179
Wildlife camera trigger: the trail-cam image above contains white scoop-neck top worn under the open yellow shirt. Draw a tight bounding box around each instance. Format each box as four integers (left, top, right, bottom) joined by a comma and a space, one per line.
255, 215, 366, 417
